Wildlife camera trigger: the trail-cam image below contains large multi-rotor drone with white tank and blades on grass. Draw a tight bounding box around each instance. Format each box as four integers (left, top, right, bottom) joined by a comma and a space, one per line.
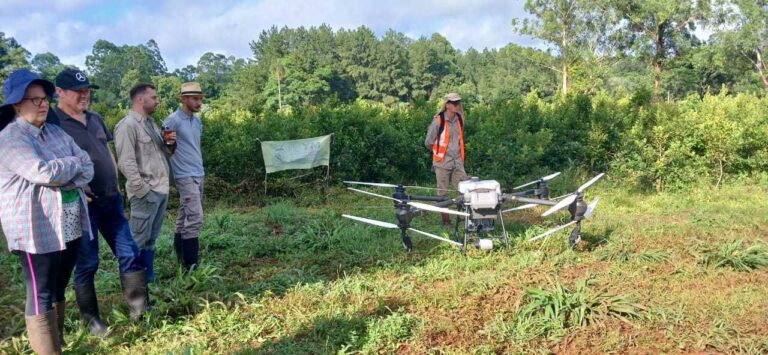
342, 172, 605, 253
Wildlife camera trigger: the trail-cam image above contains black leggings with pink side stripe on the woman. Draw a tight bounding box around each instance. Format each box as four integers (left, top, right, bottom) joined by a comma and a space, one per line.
13, 236, 79, 316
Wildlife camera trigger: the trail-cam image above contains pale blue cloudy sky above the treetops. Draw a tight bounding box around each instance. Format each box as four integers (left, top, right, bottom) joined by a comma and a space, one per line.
0, 0, 541, 71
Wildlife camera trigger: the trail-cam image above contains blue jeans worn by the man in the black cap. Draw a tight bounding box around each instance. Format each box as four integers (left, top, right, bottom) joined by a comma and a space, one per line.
75, 194, 145, 285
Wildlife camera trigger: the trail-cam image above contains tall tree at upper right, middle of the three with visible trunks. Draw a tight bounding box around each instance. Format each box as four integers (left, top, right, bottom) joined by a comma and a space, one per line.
611, 0, 711, 97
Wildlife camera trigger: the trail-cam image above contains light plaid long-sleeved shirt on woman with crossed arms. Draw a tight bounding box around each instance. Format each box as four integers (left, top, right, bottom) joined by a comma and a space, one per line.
0, 117, 93, 254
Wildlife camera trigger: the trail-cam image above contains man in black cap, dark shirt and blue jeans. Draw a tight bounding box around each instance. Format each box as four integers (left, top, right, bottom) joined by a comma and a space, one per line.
54, 69, 145, 337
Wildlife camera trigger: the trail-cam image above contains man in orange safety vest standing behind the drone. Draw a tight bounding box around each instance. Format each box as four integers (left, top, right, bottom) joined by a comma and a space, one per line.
424, 93, 467, 226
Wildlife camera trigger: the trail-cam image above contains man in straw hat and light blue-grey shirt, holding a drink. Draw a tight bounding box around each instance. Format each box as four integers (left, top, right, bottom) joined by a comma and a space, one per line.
163, 82, 205, 271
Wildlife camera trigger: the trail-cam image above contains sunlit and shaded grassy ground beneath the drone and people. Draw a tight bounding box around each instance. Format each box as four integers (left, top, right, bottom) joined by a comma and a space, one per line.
0, 182, 768, 354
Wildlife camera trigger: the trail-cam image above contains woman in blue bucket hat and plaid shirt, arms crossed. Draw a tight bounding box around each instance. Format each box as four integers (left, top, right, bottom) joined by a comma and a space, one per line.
0, 69, 93, 354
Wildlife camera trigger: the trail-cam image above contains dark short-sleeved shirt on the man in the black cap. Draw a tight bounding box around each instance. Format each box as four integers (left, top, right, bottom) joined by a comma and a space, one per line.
52, 107, 119, 202
